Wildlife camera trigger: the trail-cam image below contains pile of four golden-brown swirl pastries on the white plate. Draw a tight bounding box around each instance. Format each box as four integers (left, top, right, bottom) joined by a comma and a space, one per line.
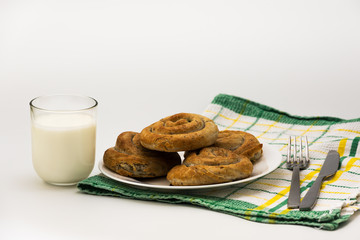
103, 113, 262, 186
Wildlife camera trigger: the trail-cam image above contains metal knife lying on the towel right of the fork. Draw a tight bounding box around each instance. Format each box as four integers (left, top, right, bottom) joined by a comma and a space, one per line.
300, 150, 340, 211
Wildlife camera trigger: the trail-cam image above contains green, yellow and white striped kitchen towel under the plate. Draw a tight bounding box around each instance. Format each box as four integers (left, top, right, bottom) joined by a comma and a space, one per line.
78, 94, 360, 230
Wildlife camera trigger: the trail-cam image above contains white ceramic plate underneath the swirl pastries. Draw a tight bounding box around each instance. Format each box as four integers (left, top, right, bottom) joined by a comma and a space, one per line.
99, 144, 282, 192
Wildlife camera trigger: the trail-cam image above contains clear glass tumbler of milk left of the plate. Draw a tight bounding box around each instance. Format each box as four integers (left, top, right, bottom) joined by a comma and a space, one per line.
30, 95, 98, 185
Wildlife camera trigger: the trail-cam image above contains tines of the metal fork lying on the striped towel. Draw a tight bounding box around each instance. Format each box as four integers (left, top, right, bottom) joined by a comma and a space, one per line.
286, 136, 310, 169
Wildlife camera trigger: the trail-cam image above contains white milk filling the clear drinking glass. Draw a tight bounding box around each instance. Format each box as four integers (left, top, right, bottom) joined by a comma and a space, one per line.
32, 114, 96, 185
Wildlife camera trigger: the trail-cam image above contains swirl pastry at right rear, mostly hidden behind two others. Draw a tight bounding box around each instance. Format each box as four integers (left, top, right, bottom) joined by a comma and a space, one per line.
212, 130, 262, 162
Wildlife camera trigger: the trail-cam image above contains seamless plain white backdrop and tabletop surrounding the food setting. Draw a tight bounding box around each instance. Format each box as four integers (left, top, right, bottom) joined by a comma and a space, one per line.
0, 0, 360, 240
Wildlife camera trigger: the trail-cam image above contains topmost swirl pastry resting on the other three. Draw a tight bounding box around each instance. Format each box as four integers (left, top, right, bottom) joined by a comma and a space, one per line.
140, 113, 219, 152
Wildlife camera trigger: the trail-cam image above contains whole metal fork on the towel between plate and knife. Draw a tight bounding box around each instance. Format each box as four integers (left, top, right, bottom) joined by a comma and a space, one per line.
286, 136, 310, 209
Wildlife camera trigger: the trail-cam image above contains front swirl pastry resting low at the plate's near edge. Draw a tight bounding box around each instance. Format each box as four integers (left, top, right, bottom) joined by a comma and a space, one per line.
167, 147, 253, 186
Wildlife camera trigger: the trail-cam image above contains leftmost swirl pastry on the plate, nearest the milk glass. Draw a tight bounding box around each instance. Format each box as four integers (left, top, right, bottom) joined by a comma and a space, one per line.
103, 132, 181, 178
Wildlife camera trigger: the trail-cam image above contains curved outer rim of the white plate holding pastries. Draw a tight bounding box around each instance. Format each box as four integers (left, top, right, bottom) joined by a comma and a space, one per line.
98, 143, 282, 191
